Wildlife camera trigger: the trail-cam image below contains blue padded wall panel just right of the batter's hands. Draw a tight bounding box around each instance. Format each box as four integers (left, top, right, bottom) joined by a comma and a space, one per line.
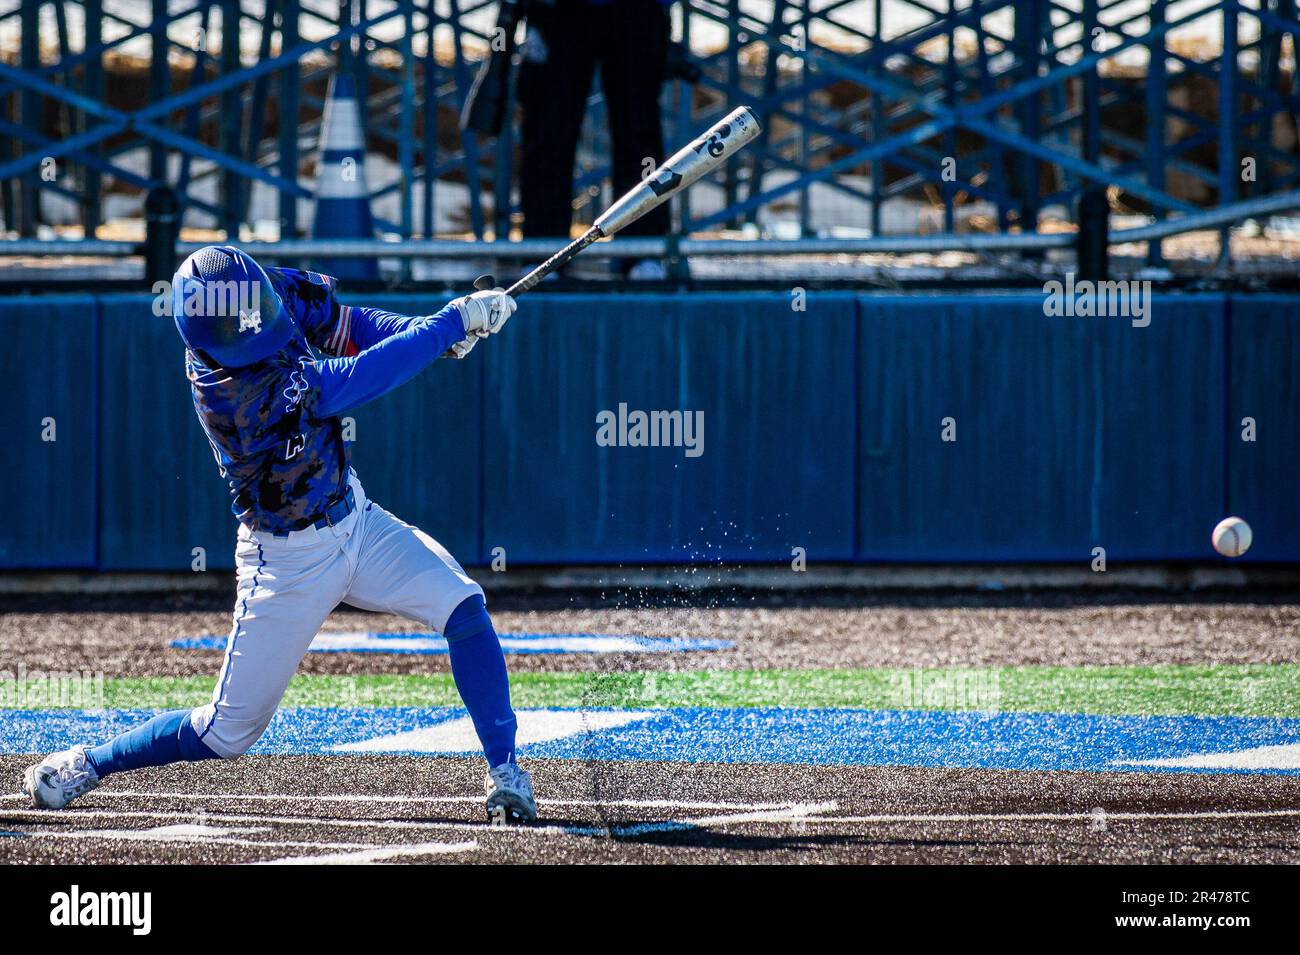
482, 294, 854, 563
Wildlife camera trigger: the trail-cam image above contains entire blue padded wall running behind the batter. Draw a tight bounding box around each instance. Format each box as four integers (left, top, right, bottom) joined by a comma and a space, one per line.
0, 292, 1300, 570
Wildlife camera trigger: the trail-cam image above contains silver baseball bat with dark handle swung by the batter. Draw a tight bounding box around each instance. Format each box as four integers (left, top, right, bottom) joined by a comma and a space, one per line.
493, 107, 759, 296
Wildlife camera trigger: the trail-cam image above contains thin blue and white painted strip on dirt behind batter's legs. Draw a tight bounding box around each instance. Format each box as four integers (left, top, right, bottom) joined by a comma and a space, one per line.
169, 631, 733, 655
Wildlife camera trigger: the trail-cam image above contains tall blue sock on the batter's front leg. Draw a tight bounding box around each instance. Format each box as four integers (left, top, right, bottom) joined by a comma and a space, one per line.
442, 595, 516, 767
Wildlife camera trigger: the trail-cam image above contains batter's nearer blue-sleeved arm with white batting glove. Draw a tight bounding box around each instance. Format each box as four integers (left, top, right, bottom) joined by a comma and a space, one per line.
312, 291, 515, 417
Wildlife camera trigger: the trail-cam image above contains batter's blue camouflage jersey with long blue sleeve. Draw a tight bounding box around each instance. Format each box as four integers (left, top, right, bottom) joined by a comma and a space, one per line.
185, 269, 465, 534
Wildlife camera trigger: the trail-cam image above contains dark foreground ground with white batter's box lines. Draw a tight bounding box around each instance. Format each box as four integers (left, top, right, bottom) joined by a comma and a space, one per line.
0, 756, 1300, 864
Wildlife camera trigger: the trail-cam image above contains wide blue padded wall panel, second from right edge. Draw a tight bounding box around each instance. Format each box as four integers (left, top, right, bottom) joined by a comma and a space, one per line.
857, 294, 1225, 561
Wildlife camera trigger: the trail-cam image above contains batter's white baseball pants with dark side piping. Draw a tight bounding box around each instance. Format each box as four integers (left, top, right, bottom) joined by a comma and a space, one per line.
190, 473, 484, 759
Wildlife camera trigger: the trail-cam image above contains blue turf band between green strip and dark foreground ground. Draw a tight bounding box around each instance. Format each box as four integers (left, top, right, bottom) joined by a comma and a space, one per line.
0, 707, 1300, 774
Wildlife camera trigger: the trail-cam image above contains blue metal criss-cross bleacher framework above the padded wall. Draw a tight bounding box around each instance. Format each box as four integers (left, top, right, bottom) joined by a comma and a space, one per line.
0, 0, 1300, 265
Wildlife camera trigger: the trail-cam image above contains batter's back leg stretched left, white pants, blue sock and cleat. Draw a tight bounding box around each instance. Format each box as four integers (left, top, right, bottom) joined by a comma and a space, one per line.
23, 537, 348, 808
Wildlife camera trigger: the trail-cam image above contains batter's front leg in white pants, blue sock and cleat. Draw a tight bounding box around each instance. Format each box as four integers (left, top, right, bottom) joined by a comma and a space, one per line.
345, 502, 537, 821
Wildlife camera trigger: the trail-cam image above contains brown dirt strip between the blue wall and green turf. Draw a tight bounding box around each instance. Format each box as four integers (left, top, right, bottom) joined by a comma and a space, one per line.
0, 592, 1300, 677
